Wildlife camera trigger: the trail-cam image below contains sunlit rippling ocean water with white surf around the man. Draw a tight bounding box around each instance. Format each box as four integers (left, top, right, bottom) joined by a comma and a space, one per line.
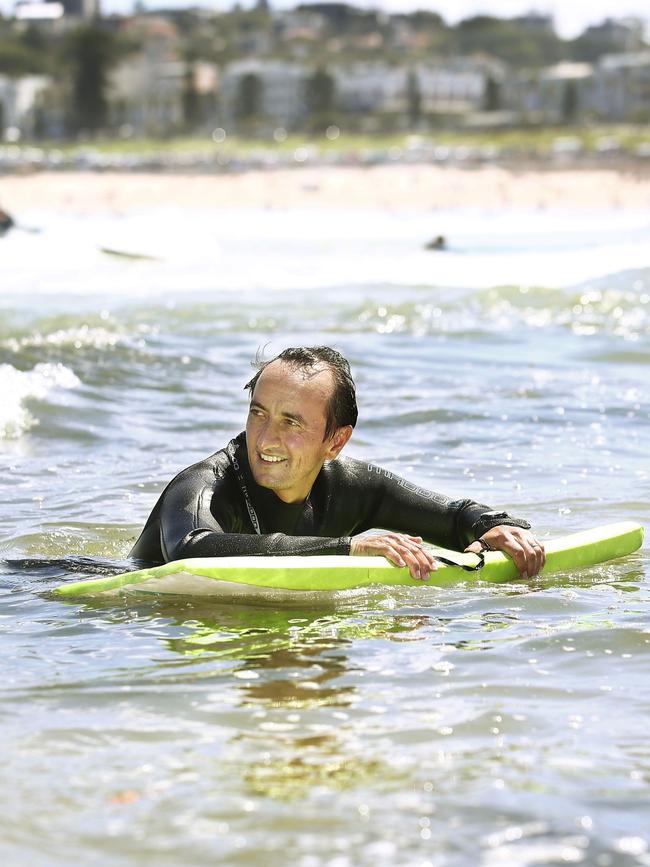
0, 200, 650, 867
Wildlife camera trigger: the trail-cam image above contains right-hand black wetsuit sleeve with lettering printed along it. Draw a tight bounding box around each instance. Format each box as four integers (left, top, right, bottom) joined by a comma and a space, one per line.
346, 462, 530, 550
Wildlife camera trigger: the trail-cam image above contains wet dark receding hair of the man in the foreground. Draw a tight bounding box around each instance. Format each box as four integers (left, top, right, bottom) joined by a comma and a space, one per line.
244, 346, 359, 440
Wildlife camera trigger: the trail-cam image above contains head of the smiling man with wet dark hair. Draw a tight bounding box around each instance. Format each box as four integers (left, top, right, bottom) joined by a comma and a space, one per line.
245, 346, 357, 503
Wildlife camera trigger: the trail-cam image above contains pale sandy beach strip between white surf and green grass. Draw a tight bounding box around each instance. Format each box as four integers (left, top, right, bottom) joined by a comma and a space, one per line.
0, 165, 650, 215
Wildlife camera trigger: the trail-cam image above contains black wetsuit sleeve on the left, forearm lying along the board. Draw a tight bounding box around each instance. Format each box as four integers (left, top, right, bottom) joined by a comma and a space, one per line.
160, 464, 350, 562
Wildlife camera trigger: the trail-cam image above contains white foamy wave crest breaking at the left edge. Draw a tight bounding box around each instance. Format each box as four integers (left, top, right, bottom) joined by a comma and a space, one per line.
0, 363, 81, 439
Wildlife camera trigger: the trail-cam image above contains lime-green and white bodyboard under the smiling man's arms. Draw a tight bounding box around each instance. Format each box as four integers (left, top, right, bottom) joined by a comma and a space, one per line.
54, 522, 643, 597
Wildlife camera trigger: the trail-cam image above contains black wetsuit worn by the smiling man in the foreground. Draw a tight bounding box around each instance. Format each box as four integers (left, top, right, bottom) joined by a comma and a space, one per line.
130, 433, 530, 563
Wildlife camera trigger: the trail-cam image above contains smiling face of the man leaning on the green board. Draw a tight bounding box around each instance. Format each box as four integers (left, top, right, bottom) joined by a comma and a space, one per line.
246, 361, 352, 503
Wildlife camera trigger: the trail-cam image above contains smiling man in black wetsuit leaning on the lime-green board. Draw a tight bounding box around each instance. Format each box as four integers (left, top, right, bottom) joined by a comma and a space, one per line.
130, 347, 544, 580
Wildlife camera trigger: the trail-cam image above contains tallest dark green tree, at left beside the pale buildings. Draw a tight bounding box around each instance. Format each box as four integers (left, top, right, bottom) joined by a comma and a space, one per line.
69, 24, 117, 132
